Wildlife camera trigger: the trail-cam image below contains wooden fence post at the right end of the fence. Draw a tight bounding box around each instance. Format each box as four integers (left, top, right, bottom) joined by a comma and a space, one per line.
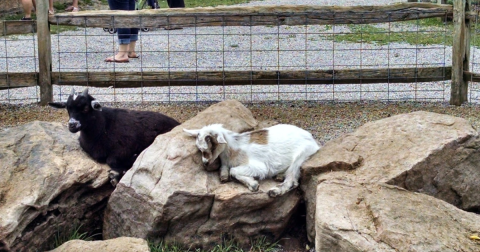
450, 0, 471, 106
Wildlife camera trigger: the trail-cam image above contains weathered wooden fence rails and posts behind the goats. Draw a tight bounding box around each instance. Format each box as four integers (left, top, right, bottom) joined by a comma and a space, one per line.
0, 0, 478, 105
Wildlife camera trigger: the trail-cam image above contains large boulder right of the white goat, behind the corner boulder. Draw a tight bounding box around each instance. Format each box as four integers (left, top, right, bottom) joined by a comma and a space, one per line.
301, 111, 480, 245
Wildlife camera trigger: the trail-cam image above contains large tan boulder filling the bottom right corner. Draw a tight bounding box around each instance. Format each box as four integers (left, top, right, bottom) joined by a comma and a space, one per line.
315, 180, 480, 252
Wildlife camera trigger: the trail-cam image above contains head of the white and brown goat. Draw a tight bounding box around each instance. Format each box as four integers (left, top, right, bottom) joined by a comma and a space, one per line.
183, 124, 227, 167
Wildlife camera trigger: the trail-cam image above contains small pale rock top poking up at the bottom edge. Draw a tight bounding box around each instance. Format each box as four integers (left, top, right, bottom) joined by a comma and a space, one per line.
50, 237, 150, 252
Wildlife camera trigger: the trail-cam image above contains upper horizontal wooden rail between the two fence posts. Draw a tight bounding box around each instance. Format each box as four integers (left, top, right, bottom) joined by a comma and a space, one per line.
49, 3, 453, 28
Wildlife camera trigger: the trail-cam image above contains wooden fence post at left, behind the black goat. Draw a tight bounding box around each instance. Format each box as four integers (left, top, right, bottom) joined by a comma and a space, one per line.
36, 0, 53, 106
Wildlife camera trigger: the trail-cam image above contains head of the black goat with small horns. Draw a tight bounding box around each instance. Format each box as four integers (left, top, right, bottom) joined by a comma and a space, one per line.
48, 88, 102, 133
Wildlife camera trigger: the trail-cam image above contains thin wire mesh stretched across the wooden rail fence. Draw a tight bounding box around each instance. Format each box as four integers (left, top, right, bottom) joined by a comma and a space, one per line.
0, 3, 458, 103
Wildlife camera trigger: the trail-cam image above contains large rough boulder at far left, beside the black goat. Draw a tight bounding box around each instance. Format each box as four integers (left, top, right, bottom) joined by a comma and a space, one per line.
0, 121, 113, 251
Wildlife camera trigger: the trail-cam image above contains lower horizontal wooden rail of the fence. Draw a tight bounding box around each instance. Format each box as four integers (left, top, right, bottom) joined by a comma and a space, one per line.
0, 67, 452, 89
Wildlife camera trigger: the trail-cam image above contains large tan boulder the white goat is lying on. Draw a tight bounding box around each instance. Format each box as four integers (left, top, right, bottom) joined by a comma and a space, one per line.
103, 101, 301, 248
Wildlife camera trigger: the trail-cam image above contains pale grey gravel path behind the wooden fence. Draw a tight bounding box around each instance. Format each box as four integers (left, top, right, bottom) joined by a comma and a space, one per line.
0, 0, 480, 103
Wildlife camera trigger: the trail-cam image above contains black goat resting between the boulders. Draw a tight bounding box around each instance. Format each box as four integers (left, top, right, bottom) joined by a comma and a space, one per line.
49, 88, 179, 185
